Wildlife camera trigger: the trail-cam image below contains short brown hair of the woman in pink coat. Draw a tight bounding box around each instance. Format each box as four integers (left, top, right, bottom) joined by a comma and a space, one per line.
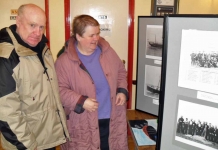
72, 14, 99, 39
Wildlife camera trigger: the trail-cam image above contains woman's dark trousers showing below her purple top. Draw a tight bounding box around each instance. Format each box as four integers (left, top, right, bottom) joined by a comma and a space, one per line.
98, 119, 110, 150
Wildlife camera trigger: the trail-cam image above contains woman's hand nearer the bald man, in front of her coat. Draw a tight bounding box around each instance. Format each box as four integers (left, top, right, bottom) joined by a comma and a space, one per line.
83, 98, 98, 112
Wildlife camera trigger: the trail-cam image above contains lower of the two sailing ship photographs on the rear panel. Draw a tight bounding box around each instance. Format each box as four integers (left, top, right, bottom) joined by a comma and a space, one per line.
144, 65, 161, 99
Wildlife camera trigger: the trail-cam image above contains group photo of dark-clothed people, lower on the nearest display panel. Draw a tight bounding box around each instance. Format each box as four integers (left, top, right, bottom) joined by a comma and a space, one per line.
175, 100, 218, 150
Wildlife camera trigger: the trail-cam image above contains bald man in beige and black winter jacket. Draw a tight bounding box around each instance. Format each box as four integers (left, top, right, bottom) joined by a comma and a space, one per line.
0, 4, 69, 150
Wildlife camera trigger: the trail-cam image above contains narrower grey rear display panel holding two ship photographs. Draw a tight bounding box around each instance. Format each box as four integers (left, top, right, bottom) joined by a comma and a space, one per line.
135, 16, 163, 116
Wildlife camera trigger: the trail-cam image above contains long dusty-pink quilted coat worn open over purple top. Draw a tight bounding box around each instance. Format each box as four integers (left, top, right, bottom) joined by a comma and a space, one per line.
55, 38, 128, 150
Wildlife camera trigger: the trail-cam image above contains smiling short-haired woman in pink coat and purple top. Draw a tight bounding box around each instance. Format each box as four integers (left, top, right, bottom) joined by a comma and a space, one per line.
55, 15, 128, 150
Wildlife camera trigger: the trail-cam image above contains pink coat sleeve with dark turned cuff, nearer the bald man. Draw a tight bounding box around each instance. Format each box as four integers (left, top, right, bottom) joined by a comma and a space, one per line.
55, 55, 87, 114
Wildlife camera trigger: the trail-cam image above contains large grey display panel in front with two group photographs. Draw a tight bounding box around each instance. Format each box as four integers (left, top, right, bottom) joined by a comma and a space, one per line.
157, 15, 218, 150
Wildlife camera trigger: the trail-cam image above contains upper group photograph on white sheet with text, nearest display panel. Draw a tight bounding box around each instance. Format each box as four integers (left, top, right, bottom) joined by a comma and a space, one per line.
178, 30, 218, 94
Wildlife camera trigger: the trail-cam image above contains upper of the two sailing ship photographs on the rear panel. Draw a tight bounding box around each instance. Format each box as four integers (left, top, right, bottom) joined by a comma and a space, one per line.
145, 25, 163, 60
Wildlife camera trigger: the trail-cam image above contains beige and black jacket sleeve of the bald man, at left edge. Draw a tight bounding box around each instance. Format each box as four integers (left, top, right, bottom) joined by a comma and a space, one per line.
0, 49, 37, 150
